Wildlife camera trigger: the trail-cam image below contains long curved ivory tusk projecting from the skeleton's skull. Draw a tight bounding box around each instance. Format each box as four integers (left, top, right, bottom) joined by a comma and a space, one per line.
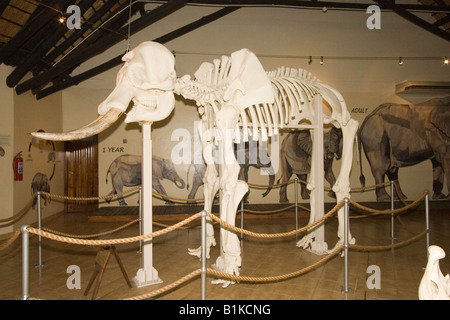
31, 108, 123, 141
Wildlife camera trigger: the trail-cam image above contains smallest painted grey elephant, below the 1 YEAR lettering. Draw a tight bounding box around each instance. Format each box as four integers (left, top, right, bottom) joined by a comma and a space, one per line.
106, 154, 185, 206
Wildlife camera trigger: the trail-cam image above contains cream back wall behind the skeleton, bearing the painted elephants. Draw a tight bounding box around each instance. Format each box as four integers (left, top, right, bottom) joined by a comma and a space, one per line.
58, 7, 450, 206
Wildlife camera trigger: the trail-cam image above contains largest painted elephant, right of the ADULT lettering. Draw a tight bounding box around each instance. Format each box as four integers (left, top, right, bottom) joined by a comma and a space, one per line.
358, 96, 450, 201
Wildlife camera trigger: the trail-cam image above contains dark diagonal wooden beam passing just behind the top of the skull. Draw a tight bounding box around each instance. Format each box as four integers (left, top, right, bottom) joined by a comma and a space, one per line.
36, 7, 239, 100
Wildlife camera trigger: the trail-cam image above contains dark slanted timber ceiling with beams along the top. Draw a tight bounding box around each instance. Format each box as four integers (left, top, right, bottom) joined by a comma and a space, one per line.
0, 0, 450, 99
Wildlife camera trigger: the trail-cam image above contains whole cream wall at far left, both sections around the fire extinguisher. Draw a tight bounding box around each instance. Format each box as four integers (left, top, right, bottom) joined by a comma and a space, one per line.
0, 60, 64, 235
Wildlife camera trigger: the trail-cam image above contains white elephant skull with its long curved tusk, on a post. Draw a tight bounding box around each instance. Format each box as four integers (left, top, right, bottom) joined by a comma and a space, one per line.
32, 41, 176, 141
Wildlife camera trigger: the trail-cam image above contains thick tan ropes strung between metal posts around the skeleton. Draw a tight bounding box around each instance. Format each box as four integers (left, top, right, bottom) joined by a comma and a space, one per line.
8, 175, 429, 300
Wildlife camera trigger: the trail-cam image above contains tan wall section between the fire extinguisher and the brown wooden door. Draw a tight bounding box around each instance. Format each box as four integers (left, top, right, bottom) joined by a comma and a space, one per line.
13, 93, 64, 228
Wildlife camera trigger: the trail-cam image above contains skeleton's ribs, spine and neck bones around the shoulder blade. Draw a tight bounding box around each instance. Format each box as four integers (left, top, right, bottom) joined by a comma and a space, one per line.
175, 56, 321, 143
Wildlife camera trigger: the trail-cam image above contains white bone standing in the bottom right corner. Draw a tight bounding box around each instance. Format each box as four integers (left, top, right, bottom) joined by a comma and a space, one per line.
419, 246, 450, 300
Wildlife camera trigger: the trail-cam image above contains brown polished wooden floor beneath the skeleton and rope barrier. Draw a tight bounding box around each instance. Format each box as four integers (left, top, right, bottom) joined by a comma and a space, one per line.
0, 201, 450, 300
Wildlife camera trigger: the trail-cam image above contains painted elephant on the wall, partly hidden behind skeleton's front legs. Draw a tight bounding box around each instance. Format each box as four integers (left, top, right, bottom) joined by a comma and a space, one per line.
187, 141, 275, 203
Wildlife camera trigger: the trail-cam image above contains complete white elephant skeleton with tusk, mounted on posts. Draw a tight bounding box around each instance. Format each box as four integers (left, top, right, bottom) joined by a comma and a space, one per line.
31, 42, 358, 286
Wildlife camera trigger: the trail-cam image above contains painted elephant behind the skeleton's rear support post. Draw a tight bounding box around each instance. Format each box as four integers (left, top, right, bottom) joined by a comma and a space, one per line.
278, 126, 342, 203
